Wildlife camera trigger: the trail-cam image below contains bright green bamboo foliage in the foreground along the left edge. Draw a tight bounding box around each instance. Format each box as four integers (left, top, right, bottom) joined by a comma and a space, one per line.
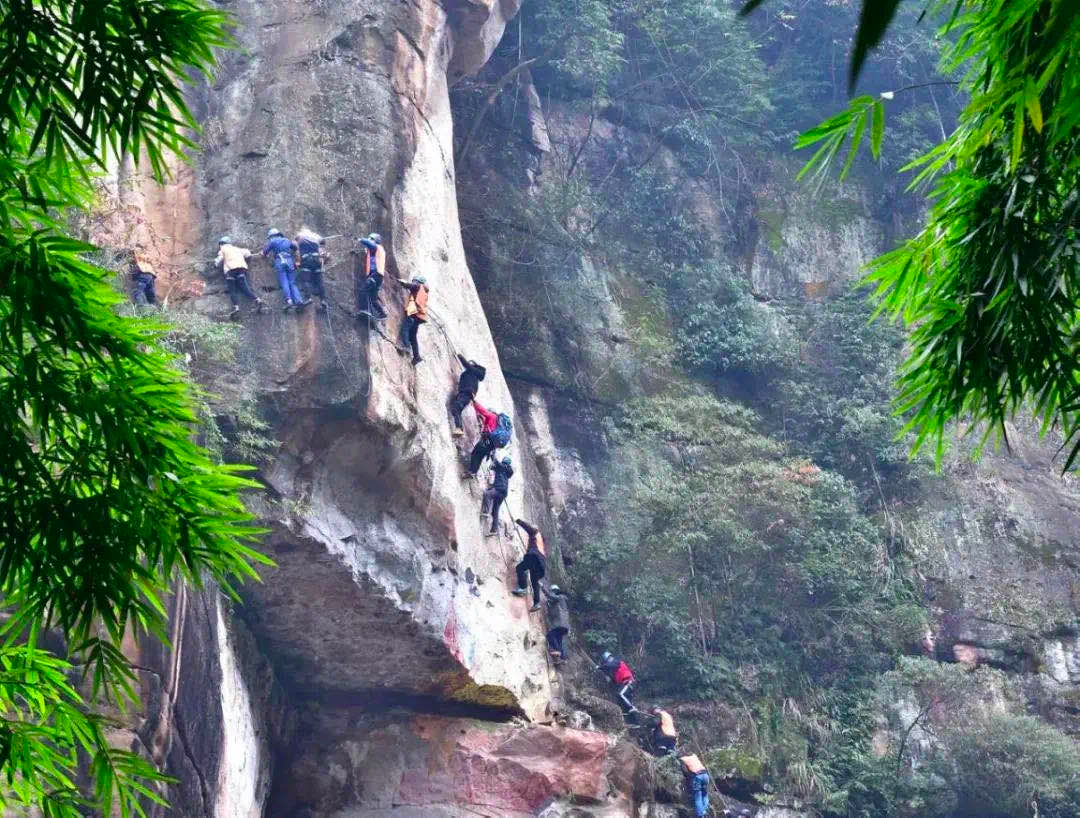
0, 0, 262, 816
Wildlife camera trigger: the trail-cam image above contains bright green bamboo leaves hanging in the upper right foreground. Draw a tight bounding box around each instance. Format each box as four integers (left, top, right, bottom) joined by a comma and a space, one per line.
746, 0, 1080, 470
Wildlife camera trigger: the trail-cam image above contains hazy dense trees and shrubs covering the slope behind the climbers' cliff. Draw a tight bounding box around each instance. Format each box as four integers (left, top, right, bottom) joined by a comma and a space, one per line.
455, 0, 1080, 818
